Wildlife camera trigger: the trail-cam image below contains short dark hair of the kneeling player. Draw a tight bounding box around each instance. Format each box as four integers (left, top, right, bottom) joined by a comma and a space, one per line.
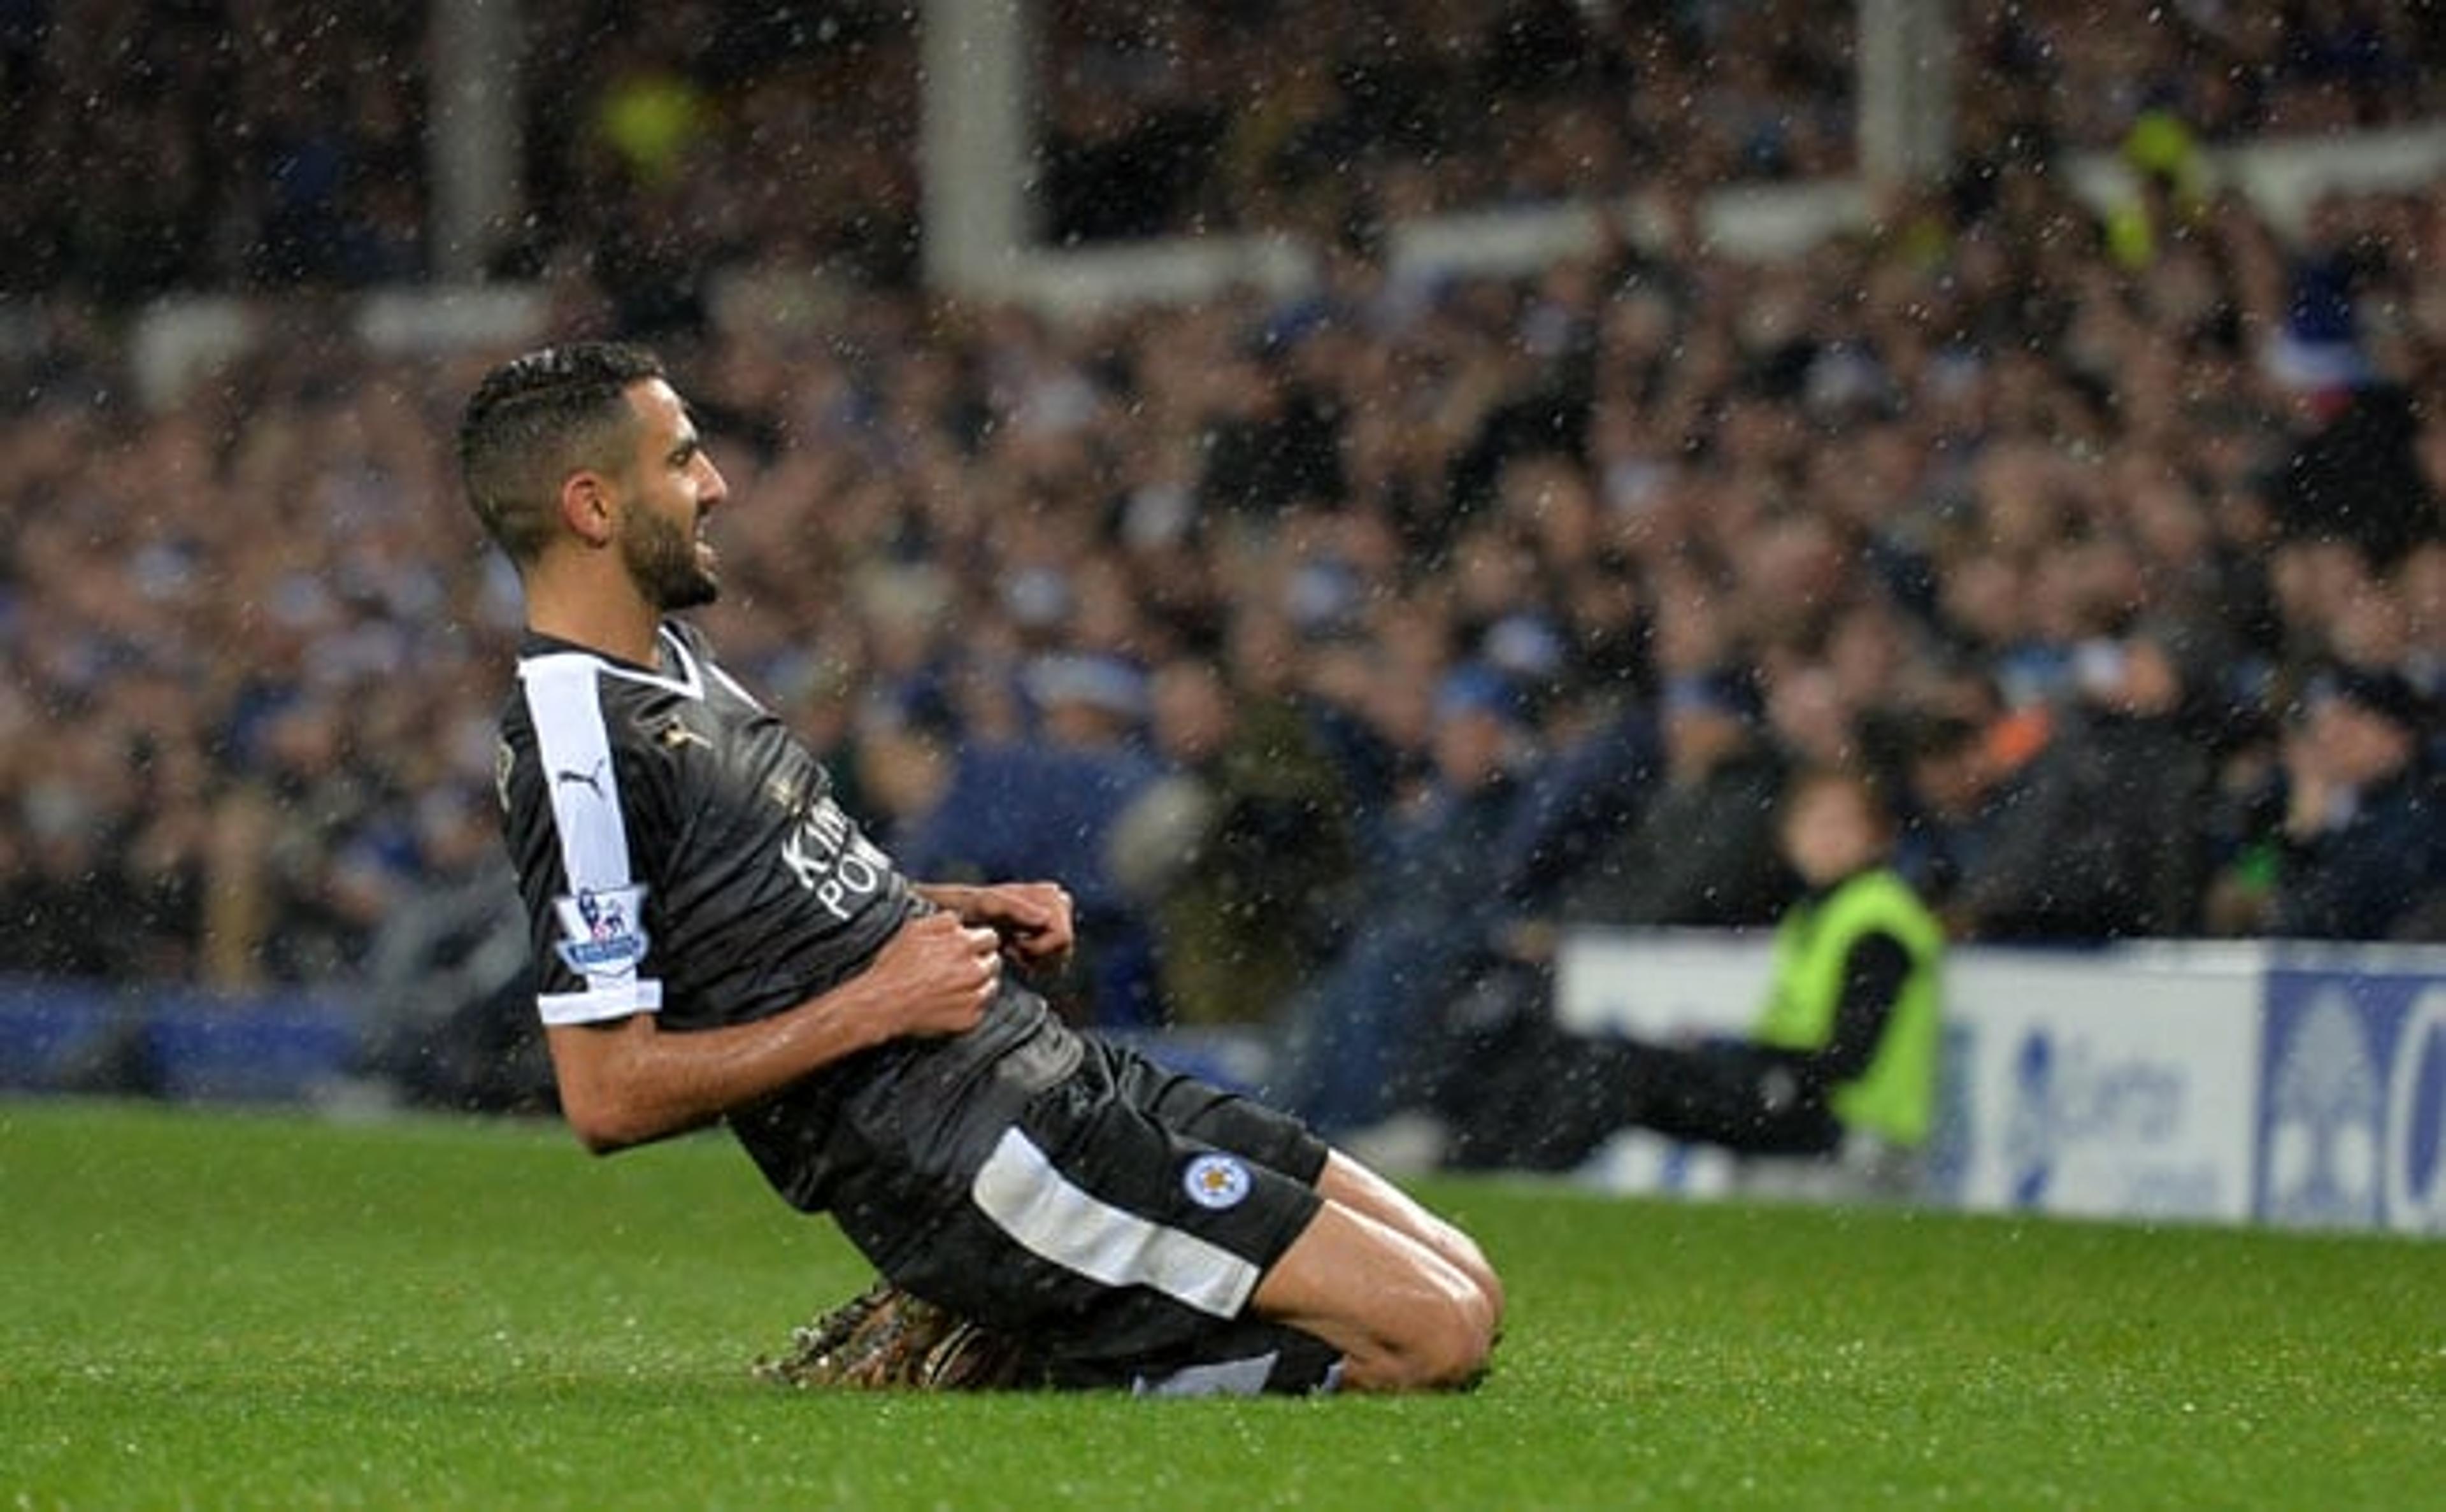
457, 340, 663, 567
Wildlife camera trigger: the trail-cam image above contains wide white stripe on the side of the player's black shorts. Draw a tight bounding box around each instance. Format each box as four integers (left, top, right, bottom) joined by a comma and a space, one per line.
969, 1128, 1257, 1319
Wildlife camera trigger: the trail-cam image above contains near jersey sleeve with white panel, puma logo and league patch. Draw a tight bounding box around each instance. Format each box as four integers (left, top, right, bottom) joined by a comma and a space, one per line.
504, 656, 663, 1025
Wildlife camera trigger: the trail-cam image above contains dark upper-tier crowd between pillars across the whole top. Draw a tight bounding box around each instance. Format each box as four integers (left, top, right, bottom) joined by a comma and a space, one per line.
0, 0, 2446, 303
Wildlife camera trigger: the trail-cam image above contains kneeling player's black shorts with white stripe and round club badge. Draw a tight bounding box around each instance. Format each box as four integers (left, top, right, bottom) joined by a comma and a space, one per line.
834, 1030, 1336, 1392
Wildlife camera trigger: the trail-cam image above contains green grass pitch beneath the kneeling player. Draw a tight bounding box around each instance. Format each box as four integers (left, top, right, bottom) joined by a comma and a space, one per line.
0, 1101, 2446, 1512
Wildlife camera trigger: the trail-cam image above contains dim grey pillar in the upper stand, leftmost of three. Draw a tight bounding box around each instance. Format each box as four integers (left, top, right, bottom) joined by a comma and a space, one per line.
426, 0, 524, 284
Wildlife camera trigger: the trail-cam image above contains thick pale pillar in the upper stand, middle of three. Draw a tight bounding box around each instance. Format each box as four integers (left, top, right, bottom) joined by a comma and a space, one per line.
917, 0, 1037, 294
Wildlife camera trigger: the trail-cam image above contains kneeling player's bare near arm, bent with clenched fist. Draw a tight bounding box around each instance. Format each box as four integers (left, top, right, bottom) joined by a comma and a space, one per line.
545, 913, 1003, 1155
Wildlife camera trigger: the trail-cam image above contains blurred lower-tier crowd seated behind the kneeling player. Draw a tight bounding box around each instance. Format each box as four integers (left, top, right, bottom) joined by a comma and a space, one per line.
0, 5, 2446, 1071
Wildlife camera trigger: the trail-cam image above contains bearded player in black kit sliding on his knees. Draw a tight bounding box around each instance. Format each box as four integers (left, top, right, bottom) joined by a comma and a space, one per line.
457, 343, 1502, 1392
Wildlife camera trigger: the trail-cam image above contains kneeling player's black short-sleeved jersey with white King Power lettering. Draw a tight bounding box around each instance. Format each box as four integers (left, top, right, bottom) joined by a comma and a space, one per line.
497, 622, 1052, 1209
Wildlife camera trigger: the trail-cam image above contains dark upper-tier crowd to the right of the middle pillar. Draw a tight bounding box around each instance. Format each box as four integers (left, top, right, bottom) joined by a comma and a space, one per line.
1042, 0, 2446, 238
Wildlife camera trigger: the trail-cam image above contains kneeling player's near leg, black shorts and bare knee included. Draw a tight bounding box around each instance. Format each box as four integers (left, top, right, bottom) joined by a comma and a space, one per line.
834, 1042, 1502, 1390
